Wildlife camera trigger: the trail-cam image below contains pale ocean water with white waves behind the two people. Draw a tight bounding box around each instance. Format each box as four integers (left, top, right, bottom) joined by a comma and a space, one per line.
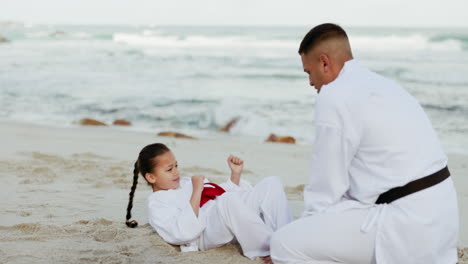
0, 24, 468, 153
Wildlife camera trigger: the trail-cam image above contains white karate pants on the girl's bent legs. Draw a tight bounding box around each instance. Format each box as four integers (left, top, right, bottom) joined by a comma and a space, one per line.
199, 177, 292, 259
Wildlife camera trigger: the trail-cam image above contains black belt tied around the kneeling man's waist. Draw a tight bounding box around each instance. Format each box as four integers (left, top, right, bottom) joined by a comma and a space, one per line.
375, 167, 450, 204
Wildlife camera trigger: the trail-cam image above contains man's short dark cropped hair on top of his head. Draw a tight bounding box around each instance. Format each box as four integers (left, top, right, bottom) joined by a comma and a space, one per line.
299, 23, 348, 54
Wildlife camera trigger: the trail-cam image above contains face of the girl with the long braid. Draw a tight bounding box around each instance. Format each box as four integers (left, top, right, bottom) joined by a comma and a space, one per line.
145, 151, 180, 191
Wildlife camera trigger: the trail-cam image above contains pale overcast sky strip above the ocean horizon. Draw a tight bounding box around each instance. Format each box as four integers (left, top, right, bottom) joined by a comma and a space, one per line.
0, 0, 468, 27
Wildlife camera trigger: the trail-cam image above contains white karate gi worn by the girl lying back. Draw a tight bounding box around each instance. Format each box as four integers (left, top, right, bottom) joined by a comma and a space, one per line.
148, 174, 292, 258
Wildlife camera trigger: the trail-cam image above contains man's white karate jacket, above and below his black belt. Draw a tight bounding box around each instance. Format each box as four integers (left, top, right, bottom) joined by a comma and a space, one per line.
304, 60, 458, 264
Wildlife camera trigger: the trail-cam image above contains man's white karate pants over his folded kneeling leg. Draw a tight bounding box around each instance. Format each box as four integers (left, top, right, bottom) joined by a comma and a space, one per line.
271, 209, 376, 264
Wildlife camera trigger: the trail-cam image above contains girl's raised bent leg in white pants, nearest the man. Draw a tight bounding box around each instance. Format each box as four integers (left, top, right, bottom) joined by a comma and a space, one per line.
239, 176, 292, 231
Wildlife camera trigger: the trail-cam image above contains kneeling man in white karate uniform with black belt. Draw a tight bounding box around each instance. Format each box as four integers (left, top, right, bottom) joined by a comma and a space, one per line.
271, 24, 458, 264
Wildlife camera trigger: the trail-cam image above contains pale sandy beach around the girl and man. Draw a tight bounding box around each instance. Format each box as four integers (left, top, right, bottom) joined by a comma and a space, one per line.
0, 121, 468, 264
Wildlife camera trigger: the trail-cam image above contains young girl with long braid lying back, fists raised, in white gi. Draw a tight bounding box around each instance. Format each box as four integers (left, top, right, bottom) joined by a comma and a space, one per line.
126, 143, 292, 260
